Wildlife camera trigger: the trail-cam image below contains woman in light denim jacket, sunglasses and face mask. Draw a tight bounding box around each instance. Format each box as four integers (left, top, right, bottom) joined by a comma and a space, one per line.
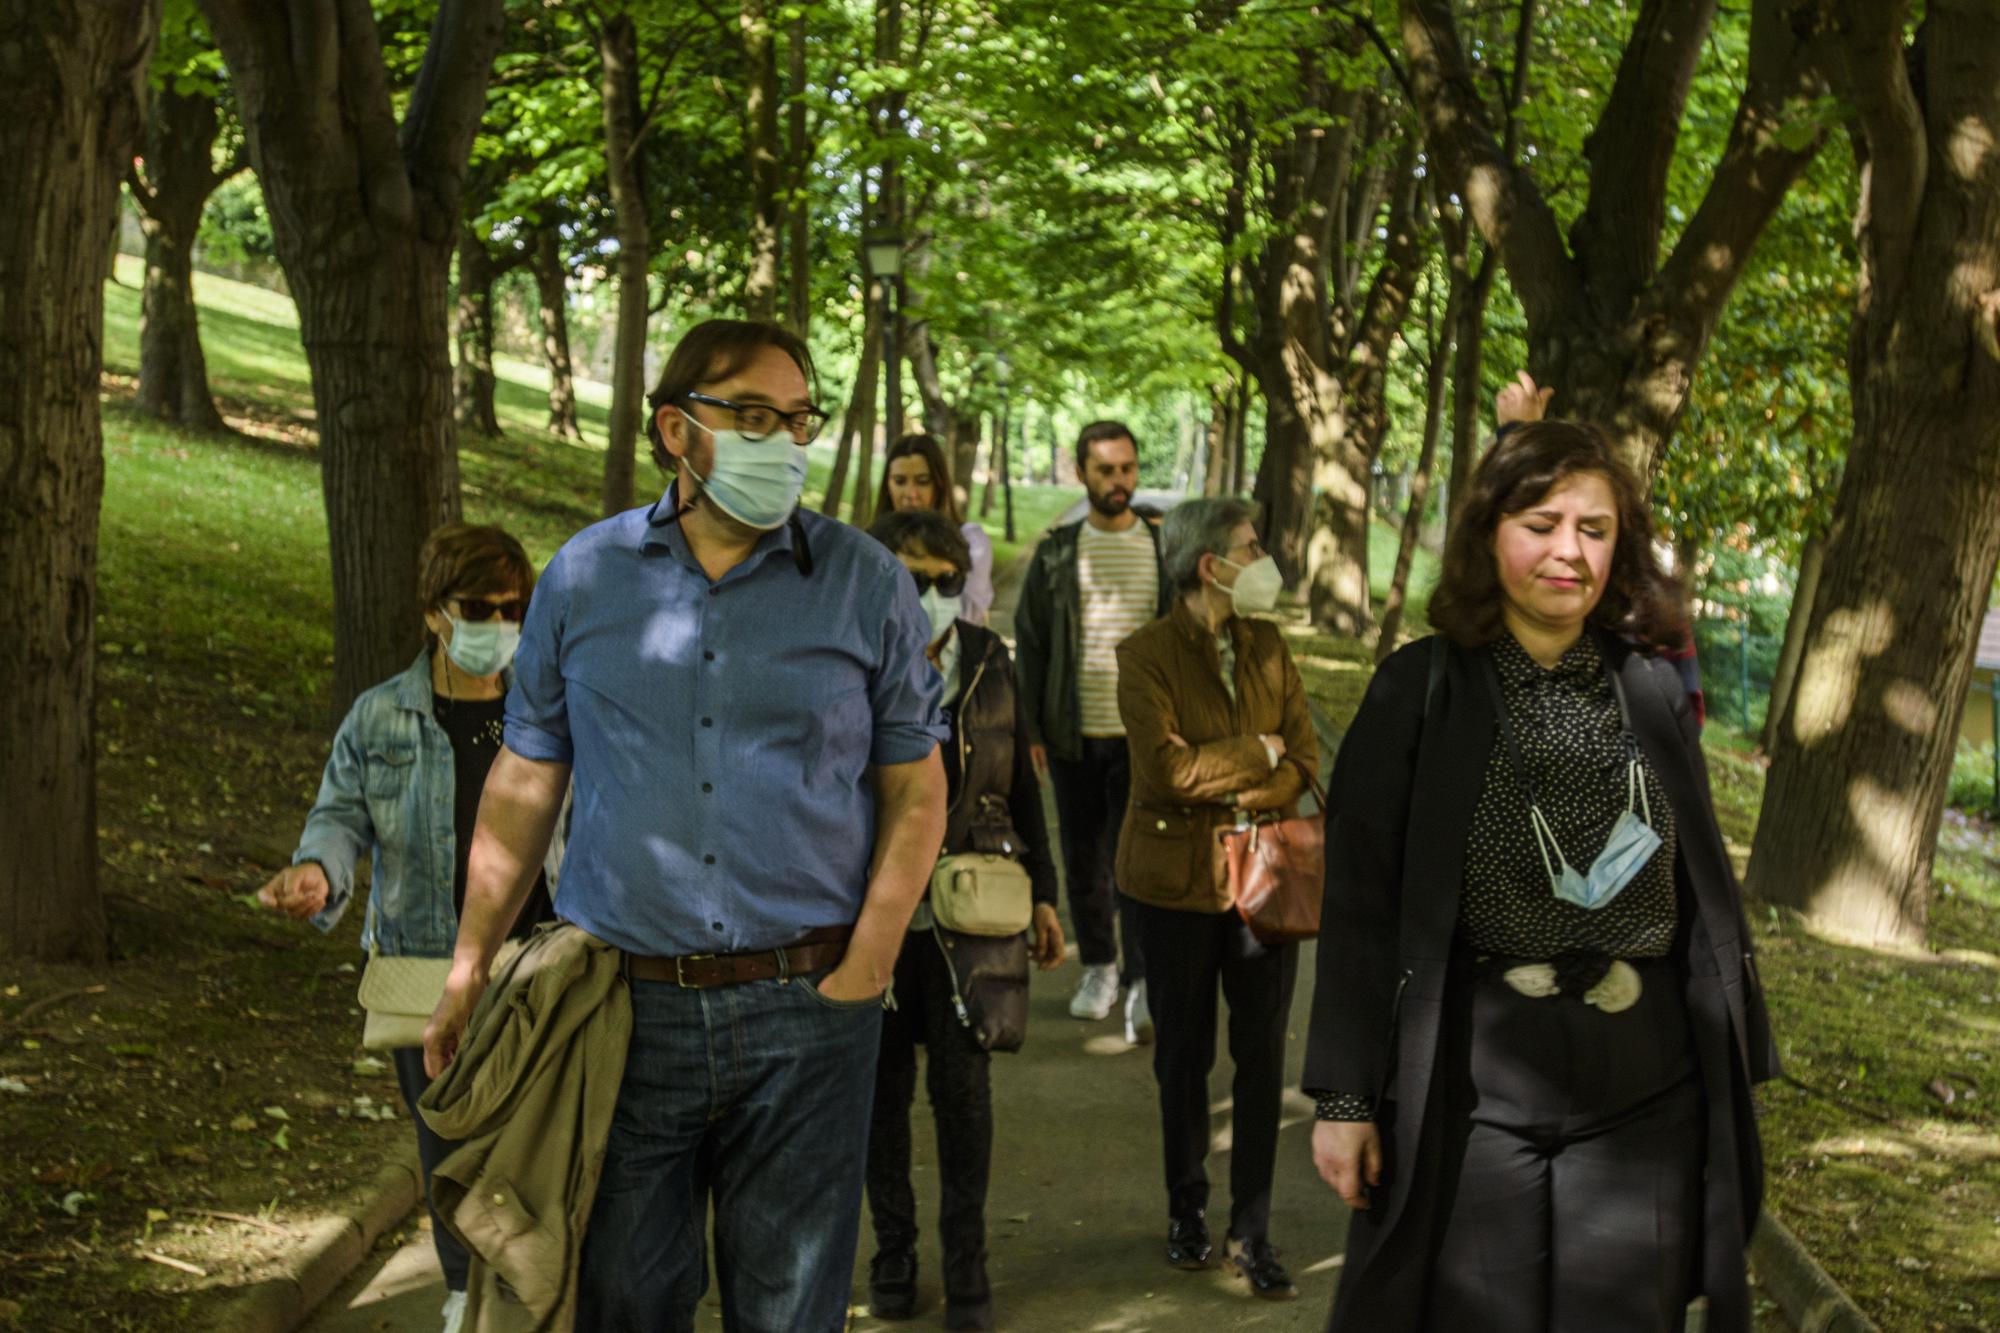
258, 522, 562, 1333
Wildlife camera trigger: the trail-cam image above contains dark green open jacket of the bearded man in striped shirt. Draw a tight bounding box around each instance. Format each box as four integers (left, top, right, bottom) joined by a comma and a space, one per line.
1014, 510, 1174, 761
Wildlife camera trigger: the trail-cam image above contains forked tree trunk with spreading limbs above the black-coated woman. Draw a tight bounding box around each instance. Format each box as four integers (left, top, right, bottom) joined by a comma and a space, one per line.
1400, 0, 1824, 474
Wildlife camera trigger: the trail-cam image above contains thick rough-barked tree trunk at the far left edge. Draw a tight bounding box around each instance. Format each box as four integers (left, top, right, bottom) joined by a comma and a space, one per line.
0, 0, 160, 963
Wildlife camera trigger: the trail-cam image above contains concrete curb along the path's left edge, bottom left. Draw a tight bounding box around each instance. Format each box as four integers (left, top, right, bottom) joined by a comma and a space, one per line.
208, 1143, 424, 1333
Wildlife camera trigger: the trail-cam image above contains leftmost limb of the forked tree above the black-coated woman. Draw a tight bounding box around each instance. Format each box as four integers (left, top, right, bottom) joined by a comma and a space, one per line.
1400, 0, 1582, 326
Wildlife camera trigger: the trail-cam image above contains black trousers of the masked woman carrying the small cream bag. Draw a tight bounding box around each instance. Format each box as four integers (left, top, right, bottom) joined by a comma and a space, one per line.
868, 935, 994, 1303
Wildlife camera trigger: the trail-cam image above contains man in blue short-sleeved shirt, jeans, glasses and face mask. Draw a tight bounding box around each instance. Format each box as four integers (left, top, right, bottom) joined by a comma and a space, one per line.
424, 320, 948, 1333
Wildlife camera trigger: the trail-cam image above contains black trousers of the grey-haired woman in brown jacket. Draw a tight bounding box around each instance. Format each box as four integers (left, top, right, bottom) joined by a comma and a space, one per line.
1126, 899, 1298, 1241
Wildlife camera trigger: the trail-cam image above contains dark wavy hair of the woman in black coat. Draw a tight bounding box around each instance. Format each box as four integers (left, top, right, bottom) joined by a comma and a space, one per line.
1430, 420, 1688, 648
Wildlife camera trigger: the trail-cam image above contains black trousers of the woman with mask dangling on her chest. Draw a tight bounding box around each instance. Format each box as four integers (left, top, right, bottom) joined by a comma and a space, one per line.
1424, 961, 1706, 1333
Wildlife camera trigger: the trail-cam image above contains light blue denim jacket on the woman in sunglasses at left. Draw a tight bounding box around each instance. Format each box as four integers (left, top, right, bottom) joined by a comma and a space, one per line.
292, 650, 562, 959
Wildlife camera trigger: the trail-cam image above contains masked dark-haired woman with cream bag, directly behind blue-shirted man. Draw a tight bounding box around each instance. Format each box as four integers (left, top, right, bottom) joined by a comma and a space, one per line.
868, 508, 1062, 1329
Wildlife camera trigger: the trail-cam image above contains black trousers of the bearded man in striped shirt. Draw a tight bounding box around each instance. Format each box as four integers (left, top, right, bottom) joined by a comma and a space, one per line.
1048, 737, 1150, 976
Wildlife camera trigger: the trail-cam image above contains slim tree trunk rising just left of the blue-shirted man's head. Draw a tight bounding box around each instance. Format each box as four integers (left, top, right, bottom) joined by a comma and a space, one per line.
598, 14, 652, 514
